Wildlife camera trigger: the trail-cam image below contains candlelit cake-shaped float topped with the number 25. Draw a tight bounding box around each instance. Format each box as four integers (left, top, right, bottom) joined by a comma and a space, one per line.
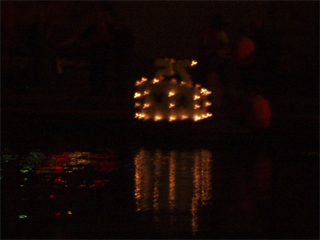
134, 58, 212, 121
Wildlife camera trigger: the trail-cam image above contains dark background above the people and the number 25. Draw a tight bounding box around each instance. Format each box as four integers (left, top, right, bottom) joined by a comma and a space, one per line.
1, 1, 319, 94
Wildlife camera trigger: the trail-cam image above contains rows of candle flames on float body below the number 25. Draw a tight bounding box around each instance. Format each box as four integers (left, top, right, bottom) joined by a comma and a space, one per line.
134, 77, 212, 122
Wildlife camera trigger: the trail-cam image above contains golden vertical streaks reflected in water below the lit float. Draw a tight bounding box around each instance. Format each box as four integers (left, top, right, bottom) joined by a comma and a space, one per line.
135, 149, 212, 232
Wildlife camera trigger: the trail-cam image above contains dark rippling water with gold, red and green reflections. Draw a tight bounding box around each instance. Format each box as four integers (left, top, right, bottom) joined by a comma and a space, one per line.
1, 143, 317, 238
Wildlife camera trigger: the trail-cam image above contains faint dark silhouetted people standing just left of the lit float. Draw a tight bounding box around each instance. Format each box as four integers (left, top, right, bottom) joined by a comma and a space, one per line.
82, 11, 135, 94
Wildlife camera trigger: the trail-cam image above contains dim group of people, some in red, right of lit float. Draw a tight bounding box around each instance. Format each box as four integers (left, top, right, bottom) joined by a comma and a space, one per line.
197, 15, 277, 128
